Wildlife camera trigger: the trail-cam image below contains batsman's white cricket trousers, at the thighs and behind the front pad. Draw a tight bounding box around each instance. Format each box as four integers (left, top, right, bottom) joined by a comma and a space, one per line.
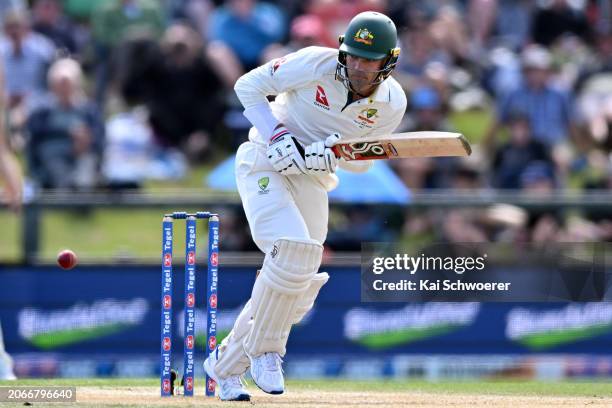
215, 142, 329, 378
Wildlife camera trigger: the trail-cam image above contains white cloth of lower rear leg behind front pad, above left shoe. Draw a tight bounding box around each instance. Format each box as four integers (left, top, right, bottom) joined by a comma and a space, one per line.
215, 300, 253, 378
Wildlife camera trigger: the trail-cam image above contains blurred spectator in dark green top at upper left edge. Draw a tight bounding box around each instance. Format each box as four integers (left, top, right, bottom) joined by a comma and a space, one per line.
91, 0, 164, 105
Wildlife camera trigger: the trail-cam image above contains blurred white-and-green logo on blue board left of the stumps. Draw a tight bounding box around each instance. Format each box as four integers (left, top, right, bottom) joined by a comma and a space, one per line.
18, 298, 149, 349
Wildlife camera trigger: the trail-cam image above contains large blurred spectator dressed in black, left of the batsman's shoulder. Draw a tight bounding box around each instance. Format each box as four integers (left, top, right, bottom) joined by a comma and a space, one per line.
117, 24, 225, 161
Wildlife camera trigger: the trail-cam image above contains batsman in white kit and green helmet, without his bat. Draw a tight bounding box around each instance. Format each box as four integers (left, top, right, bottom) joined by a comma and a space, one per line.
204, 12, 406, 401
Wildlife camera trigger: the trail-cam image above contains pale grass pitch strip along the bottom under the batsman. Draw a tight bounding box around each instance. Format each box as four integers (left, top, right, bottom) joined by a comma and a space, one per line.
0, 379, 612, 408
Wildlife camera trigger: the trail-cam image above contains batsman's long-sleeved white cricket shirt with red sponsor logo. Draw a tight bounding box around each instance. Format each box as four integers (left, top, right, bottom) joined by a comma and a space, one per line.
234, 47, 406, 146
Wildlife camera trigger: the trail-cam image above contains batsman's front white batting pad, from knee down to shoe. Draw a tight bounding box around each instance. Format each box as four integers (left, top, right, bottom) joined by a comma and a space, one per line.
244, 238, 323, 357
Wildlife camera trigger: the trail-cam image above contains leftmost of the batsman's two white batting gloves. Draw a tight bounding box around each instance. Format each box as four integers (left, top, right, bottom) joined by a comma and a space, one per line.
266, 124, 306, 175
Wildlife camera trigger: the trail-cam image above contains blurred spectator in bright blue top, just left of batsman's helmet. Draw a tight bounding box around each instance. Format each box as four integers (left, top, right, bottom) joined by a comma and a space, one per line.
207, 0, 286, 72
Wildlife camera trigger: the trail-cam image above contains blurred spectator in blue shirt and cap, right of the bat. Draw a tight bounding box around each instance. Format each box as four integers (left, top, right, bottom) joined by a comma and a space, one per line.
484, 45, 576, 152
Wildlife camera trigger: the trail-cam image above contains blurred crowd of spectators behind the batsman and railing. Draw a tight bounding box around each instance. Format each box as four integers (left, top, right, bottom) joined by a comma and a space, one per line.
0, 0, 612, 249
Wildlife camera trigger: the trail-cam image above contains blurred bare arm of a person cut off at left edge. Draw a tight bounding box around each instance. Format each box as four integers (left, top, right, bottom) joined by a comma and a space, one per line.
0, 64, 23, 210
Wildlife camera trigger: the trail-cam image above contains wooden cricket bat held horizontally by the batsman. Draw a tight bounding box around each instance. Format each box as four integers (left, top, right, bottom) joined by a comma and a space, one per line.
331, 132, 472, 161
